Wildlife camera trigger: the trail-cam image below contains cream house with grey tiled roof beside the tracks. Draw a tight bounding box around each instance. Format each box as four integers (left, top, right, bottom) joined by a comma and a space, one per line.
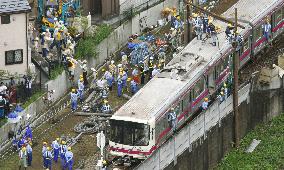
0, 0, 31, 74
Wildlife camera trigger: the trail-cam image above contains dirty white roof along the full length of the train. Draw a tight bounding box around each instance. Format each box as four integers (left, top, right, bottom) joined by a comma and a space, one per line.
111, 0, 283, 121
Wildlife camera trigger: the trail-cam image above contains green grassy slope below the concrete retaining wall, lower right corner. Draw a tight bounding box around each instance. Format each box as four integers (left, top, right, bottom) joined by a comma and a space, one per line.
217, 114, 284, 170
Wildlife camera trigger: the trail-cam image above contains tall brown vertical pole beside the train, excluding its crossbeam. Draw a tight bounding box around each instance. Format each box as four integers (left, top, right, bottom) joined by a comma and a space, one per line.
233, 8, 240, 148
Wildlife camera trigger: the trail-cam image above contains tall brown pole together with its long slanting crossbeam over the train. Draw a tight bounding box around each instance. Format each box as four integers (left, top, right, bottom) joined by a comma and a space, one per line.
188, 2, 245, 147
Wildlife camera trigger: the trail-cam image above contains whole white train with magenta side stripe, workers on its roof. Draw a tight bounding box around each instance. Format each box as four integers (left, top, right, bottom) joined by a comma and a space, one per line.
109, 0, 284, 159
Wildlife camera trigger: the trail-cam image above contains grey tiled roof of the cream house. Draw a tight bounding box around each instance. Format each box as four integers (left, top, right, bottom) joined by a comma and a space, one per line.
0, 0, 31, 14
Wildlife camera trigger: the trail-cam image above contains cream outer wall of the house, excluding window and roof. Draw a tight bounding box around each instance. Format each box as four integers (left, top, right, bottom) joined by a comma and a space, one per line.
0, 13, 31, 74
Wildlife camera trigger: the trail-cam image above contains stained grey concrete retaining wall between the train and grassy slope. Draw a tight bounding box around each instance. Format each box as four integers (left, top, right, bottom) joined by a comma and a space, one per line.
137, 80, 284, 170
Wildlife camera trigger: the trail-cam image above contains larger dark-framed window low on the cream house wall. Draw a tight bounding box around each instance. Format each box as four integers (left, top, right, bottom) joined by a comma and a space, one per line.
5, 50, 23, 65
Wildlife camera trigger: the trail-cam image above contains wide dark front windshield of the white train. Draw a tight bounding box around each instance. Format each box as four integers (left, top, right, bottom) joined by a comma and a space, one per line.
110, 120, 150, 146
